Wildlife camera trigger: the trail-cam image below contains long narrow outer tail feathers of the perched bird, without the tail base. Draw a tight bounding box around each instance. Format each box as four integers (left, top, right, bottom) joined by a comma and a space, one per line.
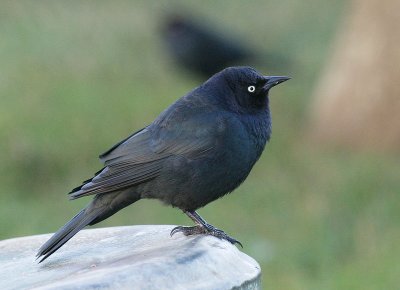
36, 209, 99, 263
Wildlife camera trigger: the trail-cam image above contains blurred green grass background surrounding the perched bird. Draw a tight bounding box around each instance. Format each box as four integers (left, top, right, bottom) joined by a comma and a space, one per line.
0, 0, 400, 289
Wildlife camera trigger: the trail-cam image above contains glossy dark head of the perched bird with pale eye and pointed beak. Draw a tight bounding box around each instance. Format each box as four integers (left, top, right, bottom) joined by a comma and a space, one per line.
208, 67, 290, 111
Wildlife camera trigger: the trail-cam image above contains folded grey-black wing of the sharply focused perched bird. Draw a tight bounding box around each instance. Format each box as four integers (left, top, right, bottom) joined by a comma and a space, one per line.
70, 104, 219, 199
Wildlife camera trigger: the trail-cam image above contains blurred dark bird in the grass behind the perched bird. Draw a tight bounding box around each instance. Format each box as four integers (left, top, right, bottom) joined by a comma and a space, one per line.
162, 14, 254, 79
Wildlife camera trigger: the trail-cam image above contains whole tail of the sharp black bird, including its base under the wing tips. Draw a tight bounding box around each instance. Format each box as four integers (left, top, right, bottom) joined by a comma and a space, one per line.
36, 191, 140, 263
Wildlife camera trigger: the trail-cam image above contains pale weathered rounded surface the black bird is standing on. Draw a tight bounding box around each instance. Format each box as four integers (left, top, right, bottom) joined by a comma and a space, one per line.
0, 226, 261, 290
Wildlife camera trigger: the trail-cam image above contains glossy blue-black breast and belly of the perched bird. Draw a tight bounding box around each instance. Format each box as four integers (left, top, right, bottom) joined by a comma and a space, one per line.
147, 111, 269, 210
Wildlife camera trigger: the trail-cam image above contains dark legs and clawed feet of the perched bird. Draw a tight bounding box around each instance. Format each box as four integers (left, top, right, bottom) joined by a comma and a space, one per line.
171, 211, 243, 248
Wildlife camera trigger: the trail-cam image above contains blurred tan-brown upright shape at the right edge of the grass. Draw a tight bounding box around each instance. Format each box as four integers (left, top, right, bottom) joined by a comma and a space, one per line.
311, 0, 400, 150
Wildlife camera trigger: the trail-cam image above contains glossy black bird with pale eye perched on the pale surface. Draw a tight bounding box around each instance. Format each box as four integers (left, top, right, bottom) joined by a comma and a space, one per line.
37, 67, 289, 262
